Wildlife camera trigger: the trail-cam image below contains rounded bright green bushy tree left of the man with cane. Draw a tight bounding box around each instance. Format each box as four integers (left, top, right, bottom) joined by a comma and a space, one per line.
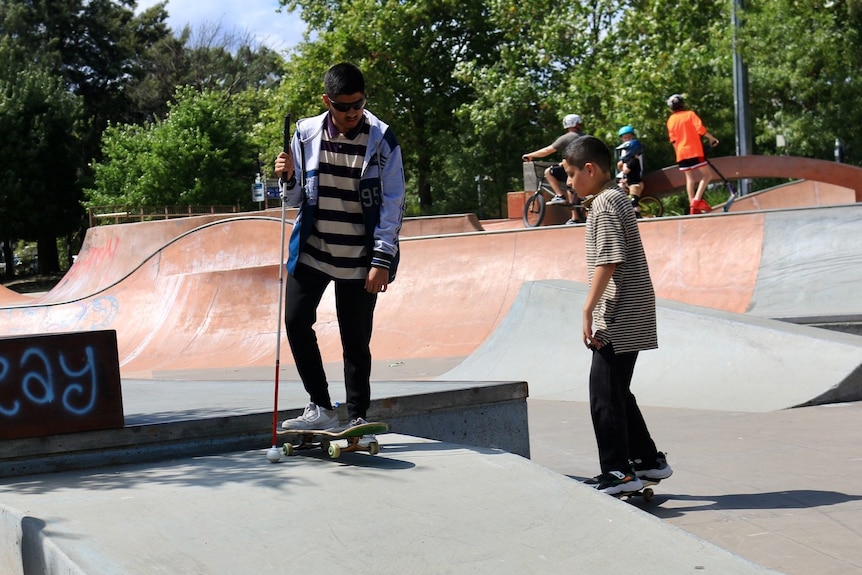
86, 87, 261, 206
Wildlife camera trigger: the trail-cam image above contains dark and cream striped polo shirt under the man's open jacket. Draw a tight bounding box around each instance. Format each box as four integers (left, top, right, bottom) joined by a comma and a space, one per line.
299, 116, 369, 280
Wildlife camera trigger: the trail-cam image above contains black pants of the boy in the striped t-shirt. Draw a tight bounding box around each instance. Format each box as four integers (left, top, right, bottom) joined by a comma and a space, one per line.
590, 344, 656, 473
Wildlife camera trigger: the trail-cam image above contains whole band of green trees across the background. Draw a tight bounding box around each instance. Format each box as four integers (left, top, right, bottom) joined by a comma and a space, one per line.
5, 0, 862, 250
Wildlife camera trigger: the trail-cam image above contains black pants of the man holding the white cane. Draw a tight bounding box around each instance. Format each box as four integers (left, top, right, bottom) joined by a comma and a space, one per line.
284, 265, 377, 419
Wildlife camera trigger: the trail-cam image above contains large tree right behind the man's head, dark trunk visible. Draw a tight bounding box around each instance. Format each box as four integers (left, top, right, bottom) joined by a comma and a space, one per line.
280, 0, 498, 213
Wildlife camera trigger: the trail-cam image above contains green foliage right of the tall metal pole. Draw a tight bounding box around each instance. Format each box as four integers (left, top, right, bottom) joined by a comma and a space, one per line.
742, 0, 862, 164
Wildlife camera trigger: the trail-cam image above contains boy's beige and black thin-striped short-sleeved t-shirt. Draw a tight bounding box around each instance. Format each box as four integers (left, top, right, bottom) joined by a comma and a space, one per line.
586, 186, 658, 353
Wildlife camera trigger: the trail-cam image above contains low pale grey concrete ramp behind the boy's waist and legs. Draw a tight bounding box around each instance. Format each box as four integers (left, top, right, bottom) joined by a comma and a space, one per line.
440, 281, 862, 412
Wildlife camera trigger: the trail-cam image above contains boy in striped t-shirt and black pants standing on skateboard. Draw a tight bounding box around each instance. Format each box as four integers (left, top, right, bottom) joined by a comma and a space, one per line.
562, 136, 673, 494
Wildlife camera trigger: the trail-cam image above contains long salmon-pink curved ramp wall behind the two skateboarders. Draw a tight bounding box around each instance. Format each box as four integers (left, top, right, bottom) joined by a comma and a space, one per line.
0, 206, 862, 390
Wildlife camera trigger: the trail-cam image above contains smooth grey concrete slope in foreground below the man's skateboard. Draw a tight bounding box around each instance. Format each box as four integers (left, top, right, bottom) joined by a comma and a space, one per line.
0, 434, 784, 575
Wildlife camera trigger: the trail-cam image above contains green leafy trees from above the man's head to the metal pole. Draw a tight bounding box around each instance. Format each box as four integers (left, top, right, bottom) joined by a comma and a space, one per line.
274, 0, 734, 216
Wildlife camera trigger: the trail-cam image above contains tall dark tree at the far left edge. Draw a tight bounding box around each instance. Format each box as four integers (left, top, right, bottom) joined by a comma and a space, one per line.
0, 0, 175, 271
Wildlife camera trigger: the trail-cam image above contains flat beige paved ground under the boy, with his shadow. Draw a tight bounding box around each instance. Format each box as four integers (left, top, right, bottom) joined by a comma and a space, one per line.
528, 400, 862, 575
